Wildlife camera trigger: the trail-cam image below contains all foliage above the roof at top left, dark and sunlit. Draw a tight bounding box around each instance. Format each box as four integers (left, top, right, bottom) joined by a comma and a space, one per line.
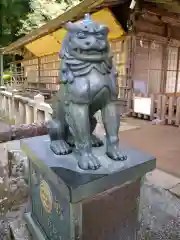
0, 0, 82, 47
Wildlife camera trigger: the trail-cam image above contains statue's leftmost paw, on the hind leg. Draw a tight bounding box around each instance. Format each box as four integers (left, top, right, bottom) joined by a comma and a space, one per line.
50, 140, 72, 155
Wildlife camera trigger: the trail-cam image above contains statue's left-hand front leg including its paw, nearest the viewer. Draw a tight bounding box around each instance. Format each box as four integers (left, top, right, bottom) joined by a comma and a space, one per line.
66, 102, 100, 170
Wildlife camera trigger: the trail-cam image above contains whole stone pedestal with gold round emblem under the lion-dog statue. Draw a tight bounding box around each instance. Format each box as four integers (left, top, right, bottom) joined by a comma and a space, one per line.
22, 136, 156, 240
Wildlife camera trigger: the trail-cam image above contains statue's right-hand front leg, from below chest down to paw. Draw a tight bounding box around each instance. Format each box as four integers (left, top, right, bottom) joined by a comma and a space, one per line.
102, 102, 127, 161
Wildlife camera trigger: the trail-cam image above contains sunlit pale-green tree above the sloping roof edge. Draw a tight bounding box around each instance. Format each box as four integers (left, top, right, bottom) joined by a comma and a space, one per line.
18, 0, 81, 35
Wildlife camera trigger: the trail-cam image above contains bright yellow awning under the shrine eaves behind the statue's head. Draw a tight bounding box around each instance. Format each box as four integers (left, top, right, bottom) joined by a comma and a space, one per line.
25, 8, 124, 57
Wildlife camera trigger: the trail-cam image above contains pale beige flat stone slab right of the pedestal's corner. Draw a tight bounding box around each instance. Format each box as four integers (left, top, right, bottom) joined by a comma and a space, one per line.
146, 169, 180, 190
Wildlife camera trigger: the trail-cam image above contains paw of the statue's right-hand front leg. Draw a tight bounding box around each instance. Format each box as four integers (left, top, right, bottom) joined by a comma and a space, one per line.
106, 144, 127, 161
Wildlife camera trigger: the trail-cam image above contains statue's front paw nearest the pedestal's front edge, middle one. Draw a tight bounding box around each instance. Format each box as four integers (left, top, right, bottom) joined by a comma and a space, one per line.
78, 153, 101, 170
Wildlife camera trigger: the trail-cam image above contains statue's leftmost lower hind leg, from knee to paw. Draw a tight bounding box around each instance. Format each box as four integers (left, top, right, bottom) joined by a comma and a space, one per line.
46, 119, 72, 155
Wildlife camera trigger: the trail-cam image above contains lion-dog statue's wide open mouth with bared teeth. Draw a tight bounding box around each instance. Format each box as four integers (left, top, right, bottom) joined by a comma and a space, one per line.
71, 49, 109, 61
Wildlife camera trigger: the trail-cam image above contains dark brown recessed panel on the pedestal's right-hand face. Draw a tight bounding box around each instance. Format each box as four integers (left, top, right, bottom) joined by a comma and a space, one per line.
82, 180, 140, 240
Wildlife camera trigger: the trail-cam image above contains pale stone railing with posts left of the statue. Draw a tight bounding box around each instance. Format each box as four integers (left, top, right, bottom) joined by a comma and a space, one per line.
0, 90, 52, 124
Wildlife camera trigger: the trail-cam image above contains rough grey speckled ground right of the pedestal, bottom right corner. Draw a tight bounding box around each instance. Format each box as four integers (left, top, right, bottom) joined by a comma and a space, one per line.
140, 182, 180, 240
